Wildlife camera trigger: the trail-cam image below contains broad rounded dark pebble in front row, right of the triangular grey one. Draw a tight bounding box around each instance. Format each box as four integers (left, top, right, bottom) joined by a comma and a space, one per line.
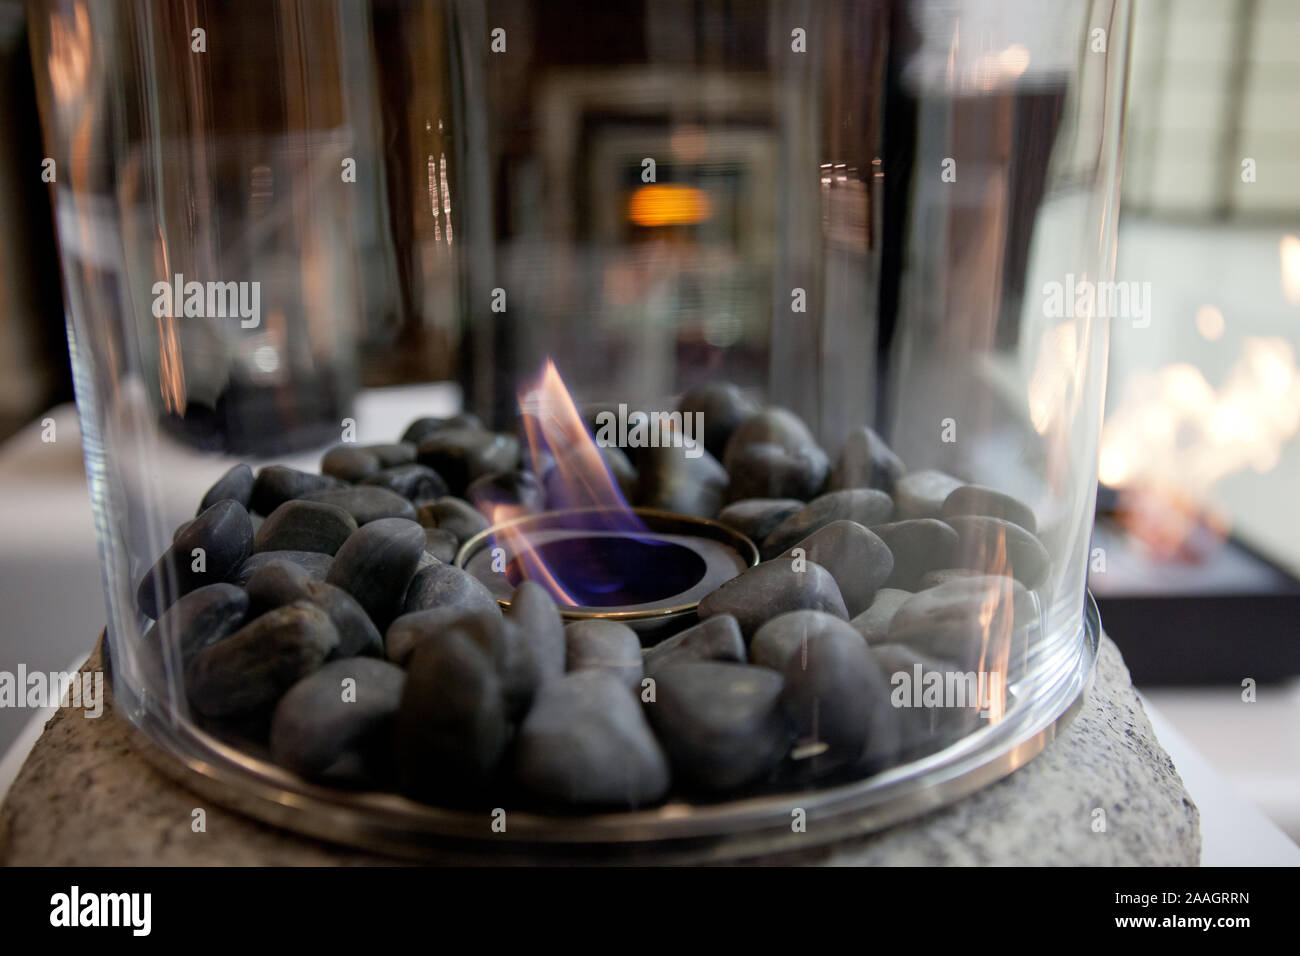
645, 661, 792, 792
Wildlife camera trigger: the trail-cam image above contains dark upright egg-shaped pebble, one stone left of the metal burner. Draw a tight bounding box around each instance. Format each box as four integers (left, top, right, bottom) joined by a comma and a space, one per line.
325, 518, 424, 631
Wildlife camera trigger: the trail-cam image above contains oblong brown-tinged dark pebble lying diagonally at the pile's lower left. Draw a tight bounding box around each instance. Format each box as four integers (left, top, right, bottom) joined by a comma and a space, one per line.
186, 601, 338, 717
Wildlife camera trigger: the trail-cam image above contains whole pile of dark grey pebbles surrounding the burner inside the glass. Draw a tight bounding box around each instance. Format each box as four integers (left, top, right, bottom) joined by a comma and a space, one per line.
138, 384, 1050, 812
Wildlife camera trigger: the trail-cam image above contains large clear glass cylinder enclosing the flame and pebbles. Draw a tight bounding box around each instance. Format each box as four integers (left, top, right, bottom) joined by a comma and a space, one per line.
33, 0, 1127, 812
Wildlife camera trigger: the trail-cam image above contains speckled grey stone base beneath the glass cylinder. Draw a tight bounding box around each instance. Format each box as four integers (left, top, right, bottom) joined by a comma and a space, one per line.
0, 639, 1201, 866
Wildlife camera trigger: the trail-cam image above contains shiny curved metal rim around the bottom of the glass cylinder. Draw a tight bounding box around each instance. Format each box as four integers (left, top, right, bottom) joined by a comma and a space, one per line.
105, 594, 1101, 864
